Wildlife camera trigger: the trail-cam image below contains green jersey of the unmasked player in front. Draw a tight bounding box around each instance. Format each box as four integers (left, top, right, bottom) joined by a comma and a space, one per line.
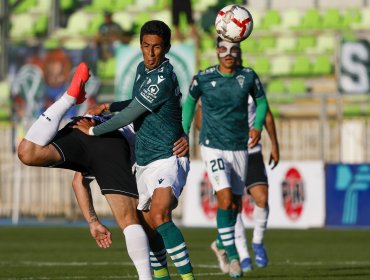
132, 59, 184, 165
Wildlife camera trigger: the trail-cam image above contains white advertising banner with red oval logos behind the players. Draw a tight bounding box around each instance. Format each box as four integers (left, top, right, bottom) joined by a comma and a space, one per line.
182, 161, 325, 228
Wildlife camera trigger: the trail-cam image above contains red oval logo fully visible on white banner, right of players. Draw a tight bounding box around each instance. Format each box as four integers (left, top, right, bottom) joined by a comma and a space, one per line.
281, 167, 305, 221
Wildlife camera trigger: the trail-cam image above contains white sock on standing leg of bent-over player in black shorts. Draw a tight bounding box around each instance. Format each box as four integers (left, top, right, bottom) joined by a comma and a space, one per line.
123, 225, 152, 280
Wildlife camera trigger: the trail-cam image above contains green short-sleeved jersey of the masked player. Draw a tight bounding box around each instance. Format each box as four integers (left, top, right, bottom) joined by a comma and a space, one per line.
189, 65, 265, 151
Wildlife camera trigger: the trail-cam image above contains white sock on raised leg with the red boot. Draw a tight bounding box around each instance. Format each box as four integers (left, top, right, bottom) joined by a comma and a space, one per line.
24, 93, 76, 146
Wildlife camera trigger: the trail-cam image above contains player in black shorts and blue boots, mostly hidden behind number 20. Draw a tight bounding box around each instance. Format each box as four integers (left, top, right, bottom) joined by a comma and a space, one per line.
195, 49, 280, 273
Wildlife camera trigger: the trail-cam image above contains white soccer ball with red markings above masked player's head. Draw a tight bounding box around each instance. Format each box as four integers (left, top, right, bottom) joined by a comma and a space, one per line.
215, 5, 253, 43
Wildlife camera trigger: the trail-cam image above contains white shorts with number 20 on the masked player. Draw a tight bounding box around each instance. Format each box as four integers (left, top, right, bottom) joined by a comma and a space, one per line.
200, 145, 248, 195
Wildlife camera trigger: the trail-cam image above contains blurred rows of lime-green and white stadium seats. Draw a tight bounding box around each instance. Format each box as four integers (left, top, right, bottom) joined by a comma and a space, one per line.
1, 0, 370, 115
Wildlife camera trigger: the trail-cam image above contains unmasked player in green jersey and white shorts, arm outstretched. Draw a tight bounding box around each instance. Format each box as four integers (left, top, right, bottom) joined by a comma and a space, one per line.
75, 20, 195, 280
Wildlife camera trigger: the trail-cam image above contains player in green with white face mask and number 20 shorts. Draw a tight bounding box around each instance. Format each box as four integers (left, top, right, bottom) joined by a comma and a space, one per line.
183, 38, 267, 278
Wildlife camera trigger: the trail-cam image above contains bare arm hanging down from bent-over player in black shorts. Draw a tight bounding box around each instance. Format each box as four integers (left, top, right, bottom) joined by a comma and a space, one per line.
72, 172, 112, 248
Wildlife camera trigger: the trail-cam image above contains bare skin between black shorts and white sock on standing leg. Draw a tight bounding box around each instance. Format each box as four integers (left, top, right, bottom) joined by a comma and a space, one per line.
105, 194, 139, 229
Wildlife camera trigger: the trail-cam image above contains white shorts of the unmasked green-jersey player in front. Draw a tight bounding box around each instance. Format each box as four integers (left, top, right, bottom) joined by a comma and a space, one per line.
136, 156, 190, 210
